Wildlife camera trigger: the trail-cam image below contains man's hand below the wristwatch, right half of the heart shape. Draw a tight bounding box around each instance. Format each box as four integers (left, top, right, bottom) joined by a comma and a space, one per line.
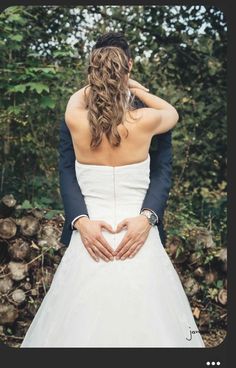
115, 215, 152, 260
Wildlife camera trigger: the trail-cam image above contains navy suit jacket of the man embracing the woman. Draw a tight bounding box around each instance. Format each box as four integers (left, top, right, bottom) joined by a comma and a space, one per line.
58, 98, 172, 246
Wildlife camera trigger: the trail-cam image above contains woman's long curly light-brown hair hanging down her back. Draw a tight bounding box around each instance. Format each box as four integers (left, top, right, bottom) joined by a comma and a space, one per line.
85, 46, 137, 150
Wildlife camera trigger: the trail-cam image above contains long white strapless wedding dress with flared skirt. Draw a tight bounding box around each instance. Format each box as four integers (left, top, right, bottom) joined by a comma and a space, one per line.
20, 155, 205, 347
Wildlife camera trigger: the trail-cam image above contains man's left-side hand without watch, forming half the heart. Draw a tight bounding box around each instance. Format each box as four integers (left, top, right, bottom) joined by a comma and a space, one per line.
74, 216, 115, 262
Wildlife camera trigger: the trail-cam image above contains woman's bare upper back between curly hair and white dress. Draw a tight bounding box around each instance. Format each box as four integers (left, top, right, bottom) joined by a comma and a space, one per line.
68, 109, 152, 166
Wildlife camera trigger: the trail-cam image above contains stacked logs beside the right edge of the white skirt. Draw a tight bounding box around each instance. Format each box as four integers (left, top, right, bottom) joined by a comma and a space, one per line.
166, 227, 227, 332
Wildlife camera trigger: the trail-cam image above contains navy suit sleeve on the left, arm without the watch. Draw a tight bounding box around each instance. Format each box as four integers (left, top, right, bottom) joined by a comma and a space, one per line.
59, 119, 89, 229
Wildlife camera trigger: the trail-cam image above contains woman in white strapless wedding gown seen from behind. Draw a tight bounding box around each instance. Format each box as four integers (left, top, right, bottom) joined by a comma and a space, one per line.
20, 46, 205, 347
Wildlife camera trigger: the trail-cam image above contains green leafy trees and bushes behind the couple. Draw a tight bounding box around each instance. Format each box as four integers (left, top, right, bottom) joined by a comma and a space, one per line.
0, 5, 227, 245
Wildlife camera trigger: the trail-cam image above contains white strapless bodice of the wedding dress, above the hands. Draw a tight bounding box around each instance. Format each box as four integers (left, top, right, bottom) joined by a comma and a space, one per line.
75, 154, 150, 226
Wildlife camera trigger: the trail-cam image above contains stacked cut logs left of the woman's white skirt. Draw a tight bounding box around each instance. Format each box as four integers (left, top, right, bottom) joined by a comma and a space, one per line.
0, 195, 65, 347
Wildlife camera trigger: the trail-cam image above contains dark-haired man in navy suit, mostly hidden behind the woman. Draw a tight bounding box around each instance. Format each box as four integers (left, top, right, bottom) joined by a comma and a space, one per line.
59, 32, 172, 251
